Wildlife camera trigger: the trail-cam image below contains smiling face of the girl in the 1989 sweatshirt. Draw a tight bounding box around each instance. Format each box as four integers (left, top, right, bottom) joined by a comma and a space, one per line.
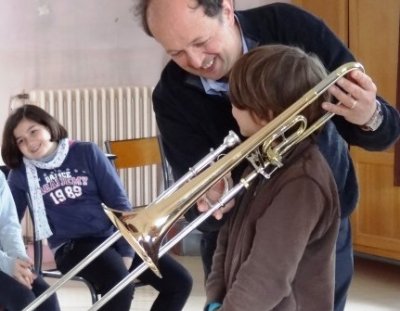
14, 119, 57, 160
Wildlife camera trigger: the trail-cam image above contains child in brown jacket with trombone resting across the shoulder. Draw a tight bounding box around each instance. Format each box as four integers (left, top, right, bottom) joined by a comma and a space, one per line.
206, 45, 339, 311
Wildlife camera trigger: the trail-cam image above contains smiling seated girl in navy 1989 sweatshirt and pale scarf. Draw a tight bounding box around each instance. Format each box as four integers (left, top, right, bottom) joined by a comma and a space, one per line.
1, 104, 192, 311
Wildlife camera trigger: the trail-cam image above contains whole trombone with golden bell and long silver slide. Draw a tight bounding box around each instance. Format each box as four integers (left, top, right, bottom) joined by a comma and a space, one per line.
23, 62, 364, 311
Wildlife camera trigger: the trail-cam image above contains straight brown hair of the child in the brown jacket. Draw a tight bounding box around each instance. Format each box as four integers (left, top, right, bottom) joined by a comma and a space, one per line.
229, 44, 329, 123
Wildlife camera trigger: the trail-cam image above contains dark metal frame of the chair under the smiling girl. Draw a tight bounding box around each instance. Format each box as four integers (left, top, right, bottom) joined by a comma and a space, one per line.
27, 194, 98, 304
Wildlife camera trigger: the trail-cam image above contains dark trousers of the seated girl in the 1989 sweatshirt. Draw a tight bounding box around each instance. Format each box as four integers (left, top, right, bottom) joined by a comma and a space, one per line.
55, 238, 192, 311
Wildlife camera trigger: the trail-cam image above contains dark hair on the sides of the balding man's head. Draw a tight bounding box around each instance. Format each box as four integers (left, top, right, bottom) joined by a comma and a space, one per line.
134, 0, 223, 37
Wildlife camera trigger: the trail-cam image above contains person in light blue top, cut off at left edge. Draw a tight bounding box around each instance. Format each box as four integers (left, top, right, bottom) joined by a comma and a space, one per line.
0, 172, 60, 311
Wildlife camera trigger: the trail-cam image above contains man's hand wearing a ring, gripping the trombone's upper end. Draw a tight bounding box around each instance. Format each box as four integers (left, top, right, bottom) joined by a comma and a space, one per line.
322, 70, 377, 126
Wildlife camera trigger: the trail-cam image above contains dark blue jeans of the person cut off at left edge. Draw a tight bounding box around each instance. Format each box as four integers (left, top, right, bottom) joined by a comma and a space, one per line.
0, 271, 60, 311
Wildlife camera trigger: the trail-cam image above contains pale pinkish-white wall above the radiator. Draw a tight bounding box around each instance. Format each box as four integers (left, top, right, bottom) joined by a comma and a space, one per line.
0, 0, 288, 161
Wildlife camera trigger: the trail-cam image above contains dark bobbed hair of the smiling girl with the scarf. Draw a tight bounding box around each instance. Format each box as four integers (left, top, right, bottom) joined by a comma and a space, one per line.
1, 104, 68, 169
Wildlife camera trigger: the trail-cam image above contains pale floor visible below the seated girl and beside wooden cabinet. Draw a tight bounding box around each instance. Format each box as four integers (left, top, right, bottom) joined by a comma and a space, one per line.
43, 257, 400, 311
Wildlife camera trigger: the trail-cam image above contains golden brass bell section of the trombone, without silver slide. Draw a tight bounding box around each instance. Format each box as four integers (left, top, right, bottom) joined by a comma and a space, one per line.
101, 63, 361, 274
